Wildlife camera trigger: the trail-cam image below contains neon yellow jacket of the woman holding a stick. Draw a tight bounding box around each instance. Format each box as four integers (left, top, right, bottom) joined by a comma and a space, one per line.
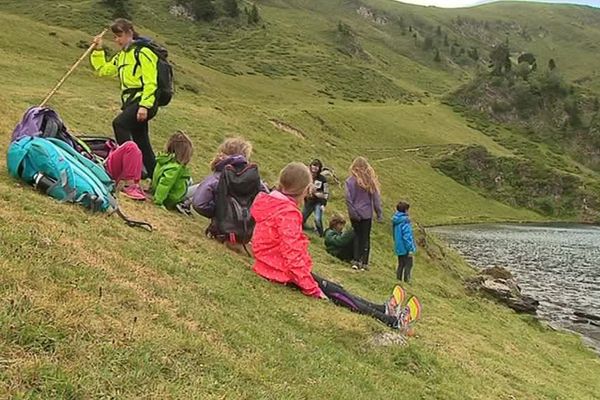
90, 43, 158, 108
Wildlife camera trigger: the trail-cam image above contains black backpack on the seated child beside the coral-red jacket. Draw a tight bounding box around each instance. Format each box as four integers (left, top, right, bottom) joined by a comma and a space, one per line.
207, 163, 261, 244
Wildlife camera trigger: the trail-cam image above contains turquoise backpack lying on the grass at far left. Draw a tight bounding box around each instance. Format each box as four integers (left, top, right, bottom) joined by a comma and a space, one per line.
6, 136, 152, 230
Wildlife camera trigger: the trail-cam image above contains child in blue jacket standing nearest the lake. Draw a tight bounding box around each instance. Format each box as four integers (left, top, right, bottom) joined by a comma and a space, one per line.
392, 201, 416, 283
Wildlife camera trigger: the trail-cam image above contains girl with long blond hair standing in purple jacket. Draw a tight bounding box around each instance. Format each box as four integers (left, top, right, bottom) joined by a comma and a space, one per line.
346, 157, 383, 270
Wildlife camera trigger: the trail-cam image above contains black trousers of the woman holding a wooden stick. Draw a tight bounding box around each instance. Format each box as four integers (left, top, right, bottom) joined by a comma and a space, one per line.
113, 102, 158, 177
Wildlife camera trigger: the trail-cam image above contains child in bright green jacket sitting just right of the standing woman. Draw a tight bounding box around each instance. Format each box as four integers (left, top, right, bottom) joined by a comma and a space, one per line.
151, 131, 193, 209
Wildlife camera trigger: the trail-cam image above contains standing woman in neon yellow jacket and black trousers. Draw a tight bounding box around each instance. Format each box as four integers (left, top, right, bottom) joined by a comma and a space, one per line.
90, 18, 158, 176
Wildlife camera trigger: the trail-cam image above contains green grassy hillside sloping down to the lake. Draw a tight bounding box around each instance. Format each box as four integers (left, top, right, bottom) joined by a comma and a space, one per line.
0, 0, 600, 399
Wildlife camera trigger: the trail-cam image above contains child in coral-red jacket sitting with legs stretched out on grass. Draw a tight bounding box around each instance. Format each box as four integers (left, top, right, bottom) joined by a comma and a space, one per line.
251, 163, 420, 329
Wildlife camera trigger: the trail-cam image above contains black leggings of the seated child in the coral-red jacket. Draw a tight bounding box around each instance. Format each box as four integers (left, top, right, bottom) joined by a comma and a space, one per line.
312, 274, 398, 327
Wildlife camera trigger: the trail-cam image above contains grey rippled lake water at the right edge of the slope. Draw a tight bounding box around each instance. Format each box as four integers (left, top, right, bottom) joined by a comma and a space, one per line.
430, 224, 600, 351
